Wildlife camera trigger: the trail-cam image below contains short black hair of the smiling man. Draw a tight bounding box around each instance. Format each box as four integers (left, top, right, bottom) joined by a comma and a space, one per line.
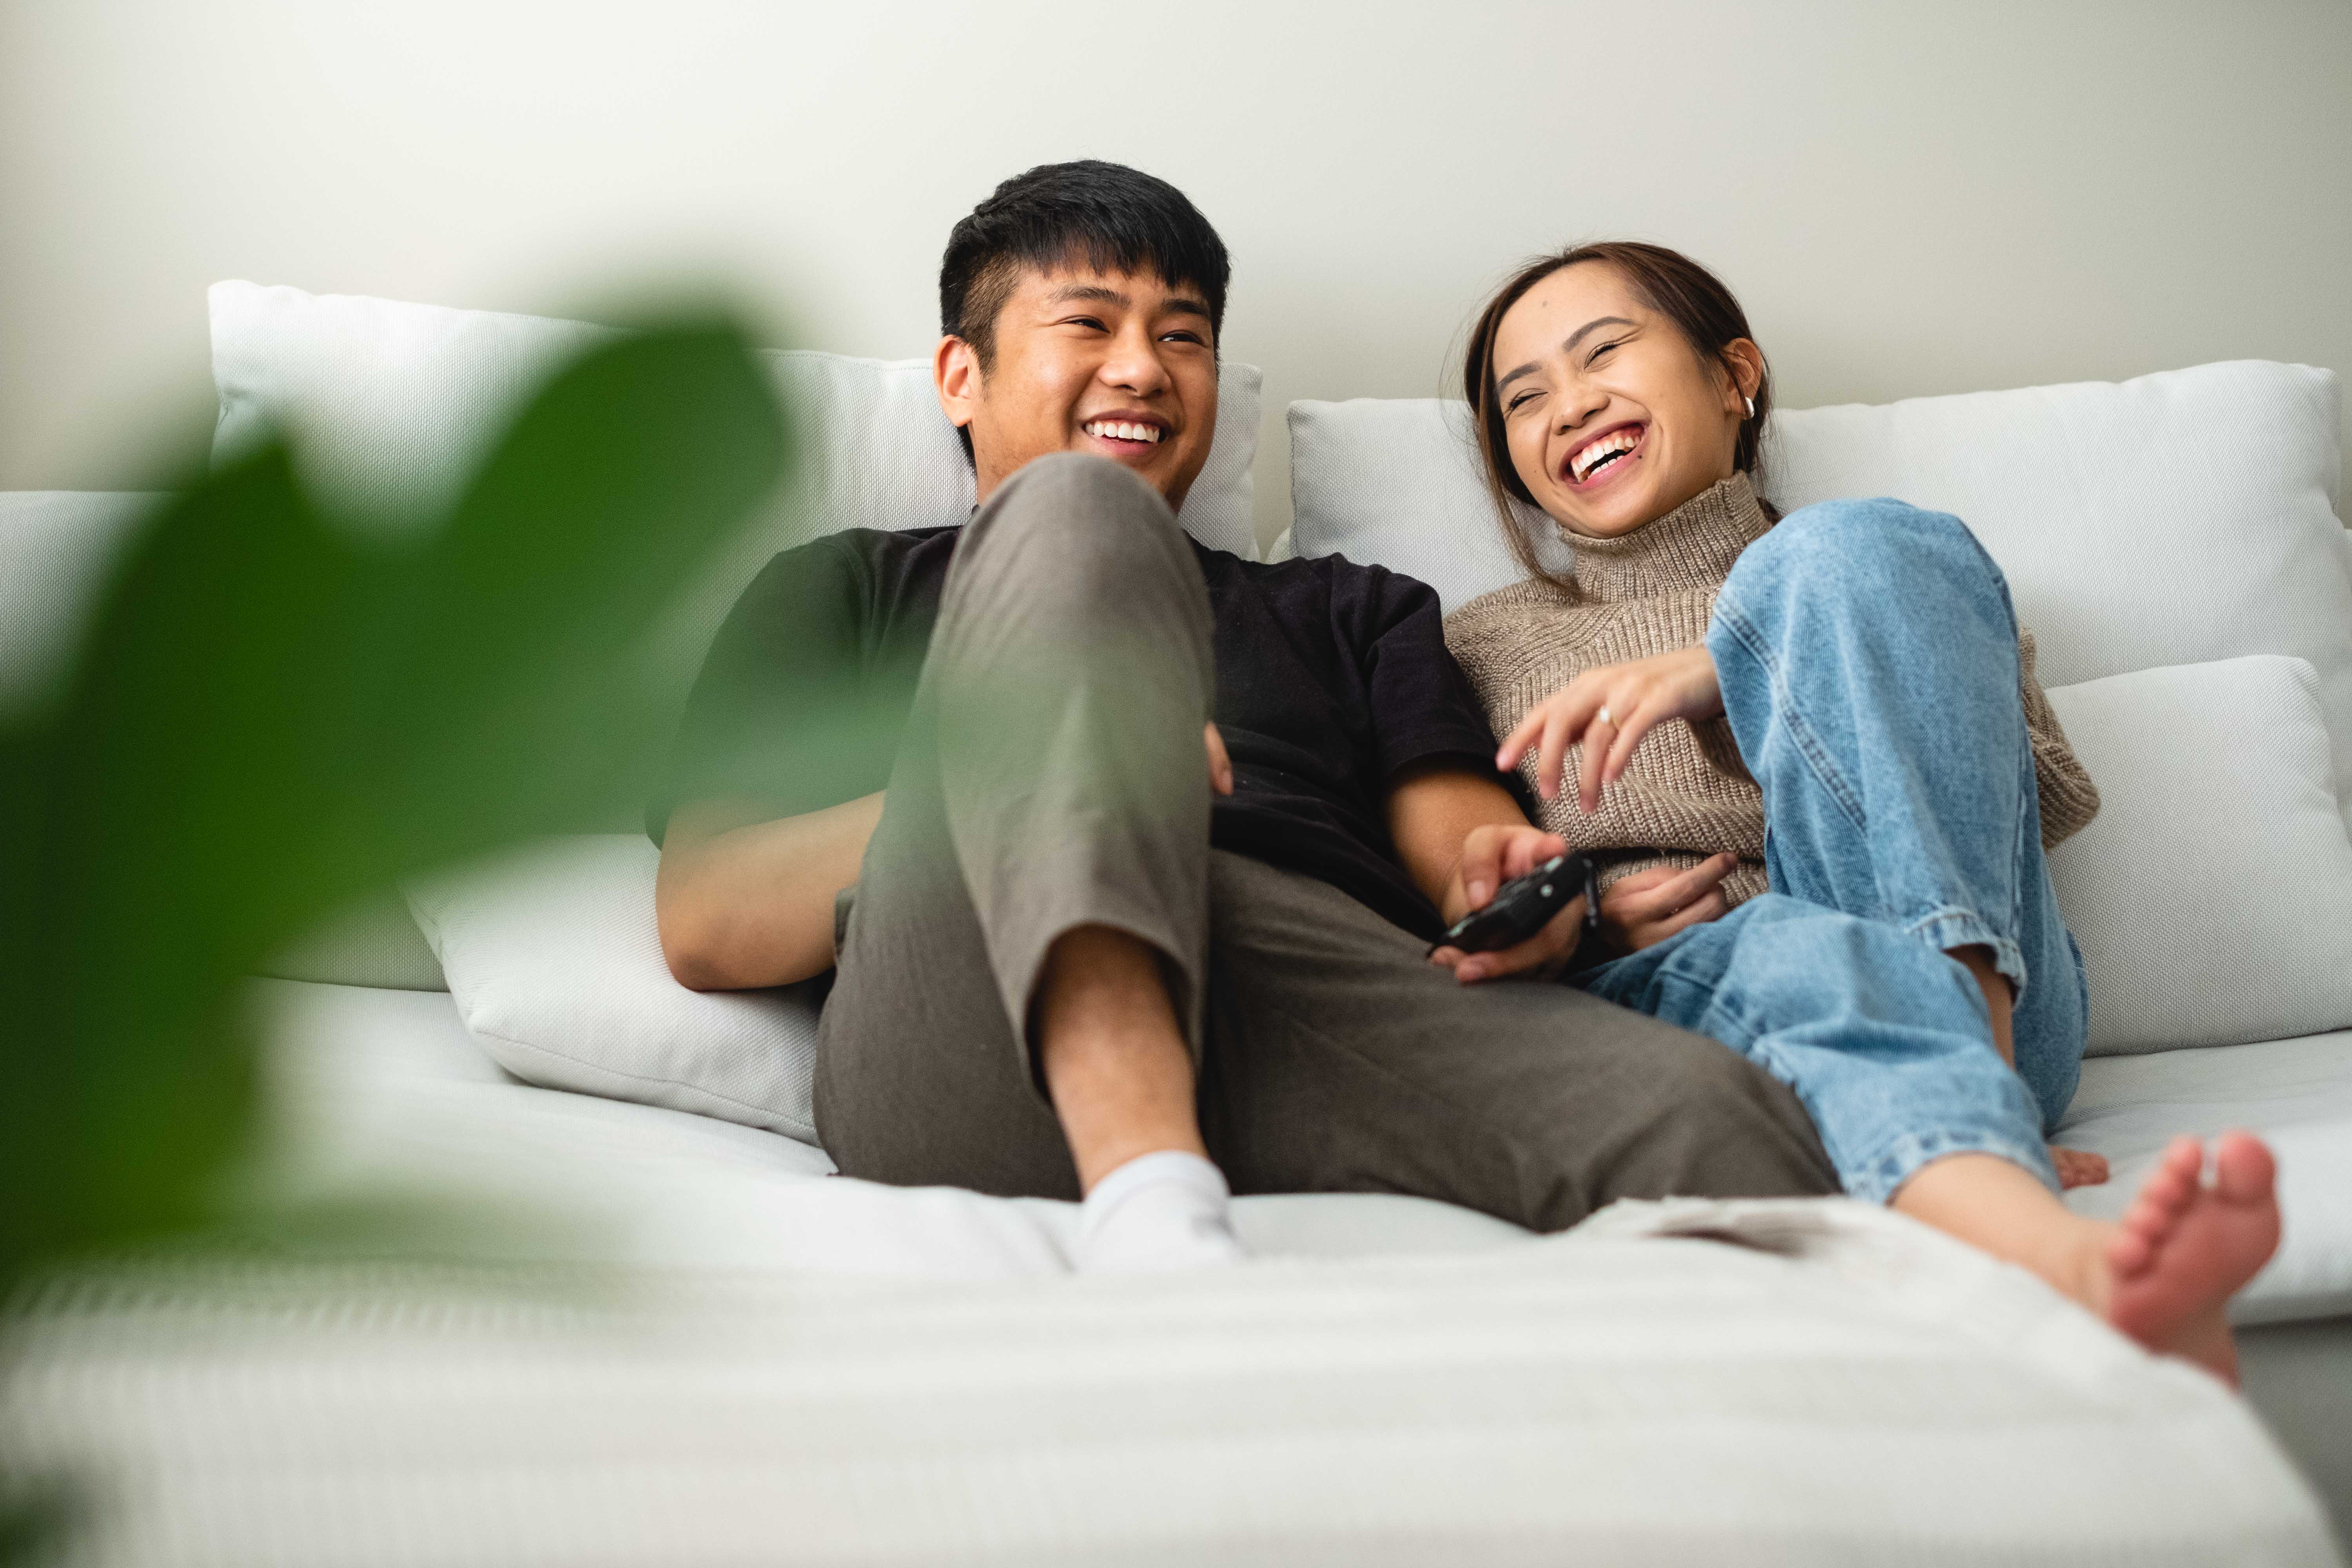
938, 158, 1232, 454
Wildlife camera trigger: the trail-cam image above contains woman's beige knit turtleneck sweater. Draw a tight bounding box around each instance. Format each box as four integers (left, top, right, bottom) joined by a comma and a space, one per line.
1446, 475, 2098, 905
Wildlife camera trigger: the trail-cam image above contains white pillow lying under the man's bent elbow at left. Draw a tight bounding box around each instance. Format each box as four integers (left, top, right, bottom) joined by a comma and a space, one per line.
407, 835, 823, 1143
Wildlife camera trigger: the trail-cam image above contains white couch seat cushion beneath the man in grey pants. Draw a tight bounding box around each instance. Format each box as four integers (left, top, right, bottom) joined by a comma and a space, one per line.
252, 980, 1529, 1279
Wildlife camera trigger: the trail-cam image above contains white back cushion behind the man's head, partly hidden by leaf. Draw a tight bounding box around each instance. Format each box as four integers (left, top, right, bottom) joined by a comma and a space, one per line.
212, 282, 1261, 562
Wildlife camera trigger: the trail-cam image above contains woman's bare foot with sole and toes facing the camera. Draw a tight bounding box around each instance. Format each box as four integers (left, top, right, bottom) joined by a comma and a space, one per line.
2107, 1133, 2279, 1385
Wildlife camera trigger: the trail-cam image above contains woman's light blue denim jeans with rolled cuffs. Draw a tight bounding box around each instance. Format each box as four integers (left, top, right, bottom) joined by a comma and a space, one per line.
1569, 501, 2089, 1201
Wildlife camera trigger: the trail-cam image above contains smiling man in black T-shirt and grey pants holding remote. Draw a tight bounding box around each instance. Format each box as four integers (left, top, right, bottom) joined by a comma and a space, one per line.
649, 162, 1835, 1269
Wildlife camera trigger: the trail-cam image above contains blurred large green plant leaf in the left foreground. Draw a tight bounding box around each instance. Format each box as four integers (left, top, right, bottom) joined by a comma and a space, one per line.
0, 325, 786, 1290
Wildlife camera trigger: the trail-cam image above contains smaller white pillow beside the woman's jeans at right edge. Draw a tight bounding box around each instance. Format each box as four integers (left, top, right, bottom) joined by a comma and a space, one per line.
2049, 656, 2352, 1056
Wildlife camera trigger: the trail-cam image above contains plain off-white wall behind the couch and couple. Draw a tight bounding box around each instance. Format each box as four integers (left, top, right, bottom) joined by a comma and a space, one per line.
0, 0, 2352, 552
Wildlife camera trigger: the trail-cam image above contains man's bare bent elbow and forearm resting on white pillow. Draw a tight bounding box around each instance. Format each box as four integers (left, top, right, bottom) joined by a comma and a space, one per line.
654, 790, 882, 990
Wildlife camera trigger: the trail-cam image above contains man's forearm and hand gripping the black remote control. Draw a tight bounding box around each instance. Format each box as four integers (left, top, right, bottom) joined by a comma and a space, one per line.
1388, 762, 1585, 980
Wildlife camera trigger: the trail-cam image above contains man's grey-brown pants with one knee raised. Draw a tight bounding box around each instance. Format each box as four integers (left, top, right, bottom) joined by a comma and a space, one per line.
816, 456, 1837, 1232
